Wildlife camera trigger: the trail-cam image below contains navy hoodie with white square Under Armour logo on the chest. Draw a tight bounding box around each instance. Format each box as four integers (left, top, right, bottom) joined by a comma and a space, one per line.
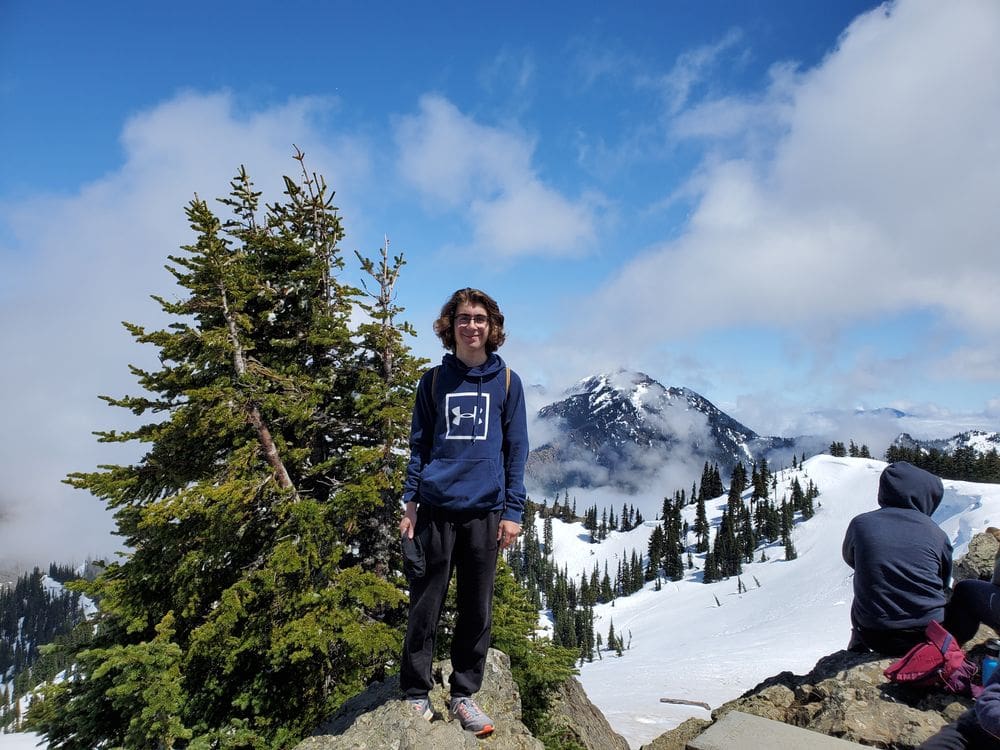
403, 353, 528, 523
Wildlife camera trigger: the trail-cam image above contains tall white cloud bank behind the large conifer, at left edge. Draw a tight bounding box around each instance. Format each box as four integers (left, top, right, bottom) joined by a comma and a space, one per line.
0, 93, 368, 564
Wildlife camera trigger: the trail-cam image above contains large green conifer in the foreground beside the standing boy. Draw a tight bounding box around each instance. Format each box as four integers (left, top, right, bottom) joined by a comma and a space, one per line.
39, 159, 418, 748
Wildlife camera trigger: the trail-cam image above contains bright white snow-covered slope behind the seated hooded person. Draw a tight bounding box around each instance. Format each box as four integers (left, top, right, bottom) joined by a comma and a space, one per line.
539, 456, 1000, 747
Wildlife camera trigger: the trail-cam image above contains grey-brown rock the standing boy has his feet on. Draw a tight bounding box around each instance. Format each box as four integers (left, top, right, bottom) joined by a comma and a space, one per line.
296, 649, 628, 750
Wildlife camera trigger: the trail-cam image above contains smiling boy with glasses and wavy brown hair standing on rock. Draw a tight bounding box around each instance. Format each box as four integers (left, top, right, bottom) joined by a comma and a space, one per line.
399, 289, 528, 737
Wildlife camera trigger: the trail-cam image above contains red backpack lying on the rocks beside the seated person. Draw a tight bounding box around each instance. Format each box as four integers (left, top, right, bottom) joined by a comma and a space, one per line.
883, 620, 979, 695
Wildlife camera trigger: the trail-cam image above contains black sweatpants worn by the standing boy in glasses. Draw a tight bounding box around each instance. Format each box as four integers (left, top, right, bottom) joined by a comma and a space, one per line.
399, 504, 500, 698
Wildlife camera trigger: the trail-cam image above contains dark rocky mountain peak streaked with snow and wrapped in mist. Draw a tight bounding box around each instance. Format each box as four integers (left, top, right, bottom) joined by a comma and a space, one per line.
528, 370, 795, 492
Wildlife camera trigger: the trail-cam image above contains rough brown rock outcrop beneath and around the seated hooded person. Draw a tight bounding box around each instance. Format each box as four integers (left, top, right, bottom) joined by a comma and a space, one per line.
643, 534, 1000, 750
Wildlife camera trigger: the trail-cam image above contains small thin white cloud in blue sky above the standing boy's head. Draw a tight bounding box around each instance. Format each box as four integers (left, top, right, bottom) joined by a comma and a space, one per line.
396, 95, 596, 258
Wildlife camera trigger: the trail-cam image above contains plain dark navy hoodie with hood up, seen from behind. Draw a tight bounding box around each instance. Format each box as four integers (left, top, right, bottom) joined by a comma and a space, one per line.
843, 461, 952, 630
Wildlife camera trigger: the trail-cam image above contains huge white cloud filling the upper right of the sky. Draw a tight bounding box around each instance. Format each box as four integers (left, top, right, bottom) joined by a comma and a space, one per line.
574, 0, 1000, 368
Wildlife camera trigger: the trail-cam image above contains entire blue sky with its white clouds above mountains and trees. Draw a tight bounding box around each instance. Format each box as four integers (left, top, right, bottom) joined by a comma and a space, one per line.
0, 0, 1000, 564
